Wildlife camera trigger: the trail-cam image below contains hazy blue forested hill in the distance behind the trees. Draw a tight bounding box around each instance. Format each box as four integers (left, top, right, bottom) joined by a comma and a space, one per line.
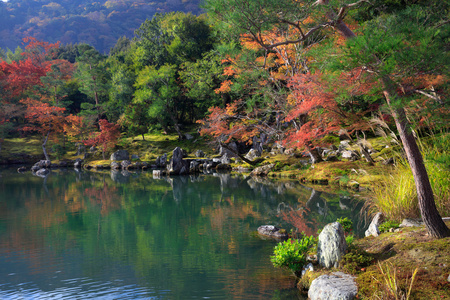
0, 0, 202, 53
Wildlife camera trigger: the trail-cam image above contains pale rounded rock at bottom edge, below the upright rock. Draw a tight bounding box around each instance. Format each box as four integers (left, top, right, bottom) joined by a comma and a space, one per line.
308, 272, 358, 300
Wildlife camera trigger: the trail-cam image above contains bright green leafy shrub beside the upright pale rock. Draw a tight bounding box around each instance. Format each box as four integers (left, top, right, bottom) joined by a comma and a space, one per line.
270, 236, 317, 276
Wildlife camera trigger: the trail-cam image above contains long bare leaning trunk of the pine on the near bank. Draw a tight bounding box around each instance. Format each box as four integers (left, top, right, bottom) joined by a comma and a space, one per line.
382, 76, 450, 238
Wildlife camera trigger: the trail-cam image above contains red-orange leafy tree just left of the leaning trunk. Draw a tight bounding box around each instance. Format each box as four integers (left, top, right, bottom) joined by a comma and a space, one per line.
284, 69, 377, 161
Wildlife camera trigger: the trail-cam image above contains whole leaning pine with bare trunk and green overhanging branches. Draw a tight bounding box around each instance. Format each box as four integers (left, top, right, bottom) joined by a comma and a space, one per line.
206, 0, 450, 238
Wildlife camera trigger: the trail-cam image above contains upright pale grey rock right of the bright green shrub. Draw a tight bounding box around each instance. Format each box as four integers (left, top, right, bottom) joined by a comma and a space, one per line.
317, 222, 347, 268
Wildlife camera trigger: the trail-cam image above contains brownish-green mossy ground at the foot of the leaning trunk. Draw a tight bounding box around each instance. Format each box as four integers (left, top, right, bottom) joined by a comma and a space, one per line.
352, 222, 450, 299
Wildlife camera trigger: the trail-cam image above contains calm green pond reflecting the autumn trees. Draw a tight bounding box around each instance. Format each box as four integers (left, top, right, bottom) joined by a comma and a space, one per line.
0, 169, 364, 299
